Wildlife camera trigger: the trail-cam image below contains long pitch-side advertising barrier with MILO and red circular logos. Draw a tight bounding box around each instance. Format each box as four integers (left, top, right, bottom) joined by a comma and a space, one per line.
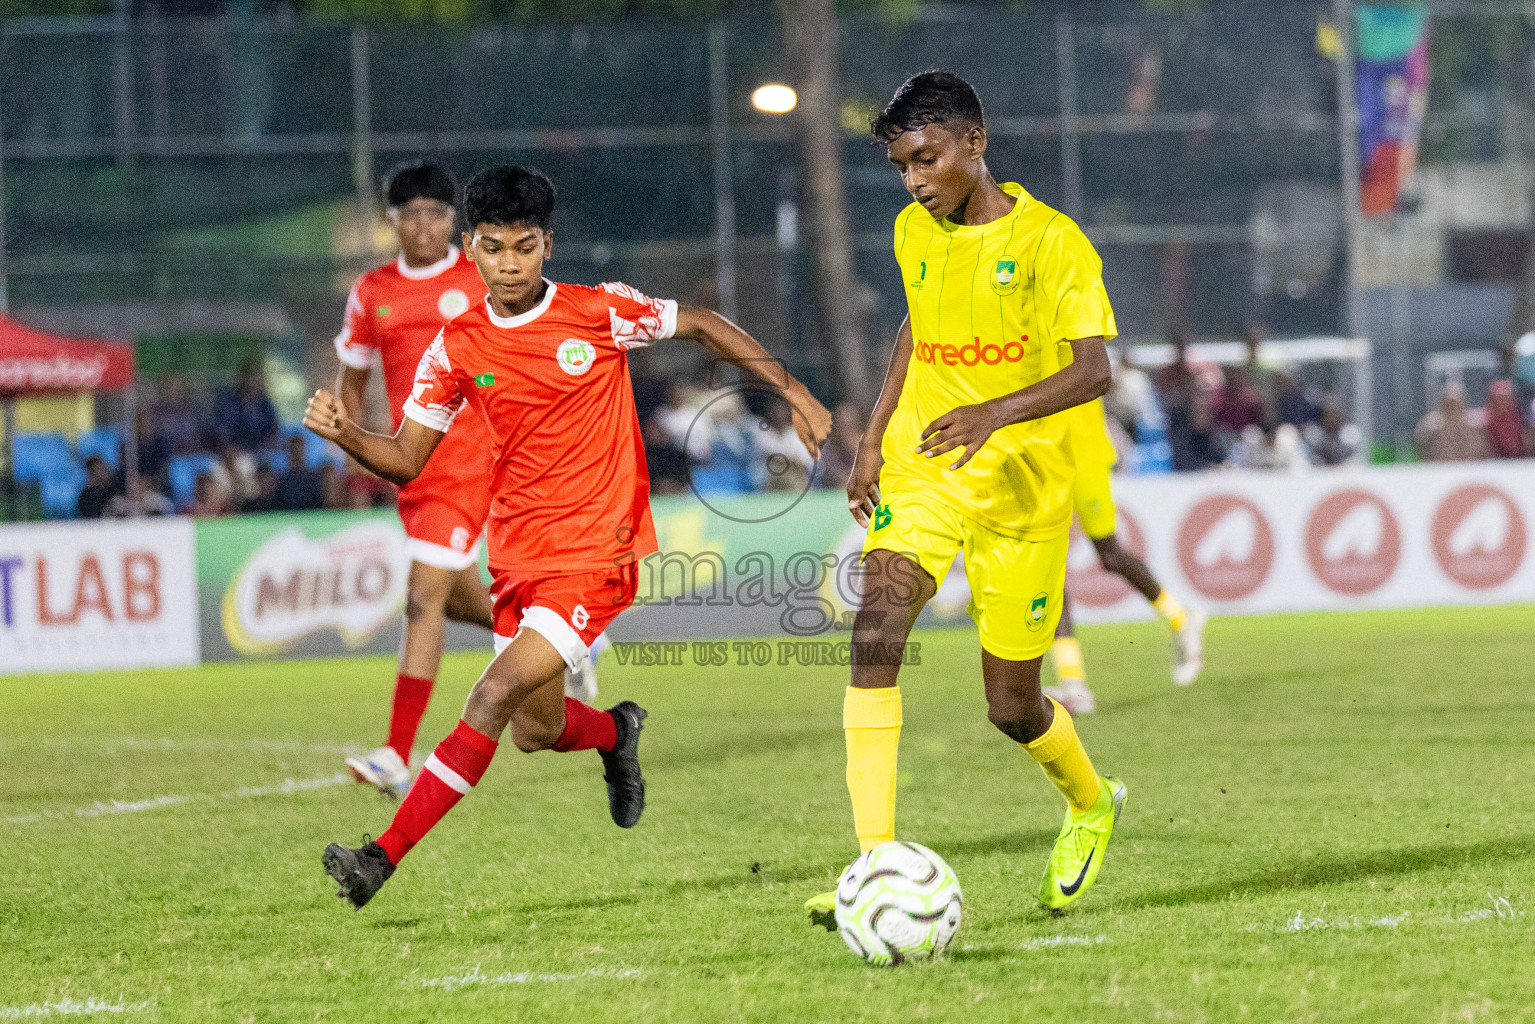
0, 462, 1535, 672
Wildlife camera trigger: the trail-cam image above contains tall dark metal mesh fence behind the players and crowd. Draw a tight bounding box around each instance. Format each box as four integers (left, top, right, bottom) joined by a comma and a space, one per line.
0, 3, 1522, 408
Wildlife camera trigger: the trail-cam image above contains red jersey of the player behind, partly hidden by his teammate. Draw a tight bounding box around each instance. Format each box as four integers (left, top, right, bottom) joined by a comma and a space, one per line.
336, 247, 491, 510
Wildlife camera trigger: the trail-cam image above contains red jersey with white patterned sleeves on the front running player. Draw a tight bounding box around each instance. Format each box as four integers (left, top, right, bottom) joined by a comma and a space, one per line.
405, 281, 677, 574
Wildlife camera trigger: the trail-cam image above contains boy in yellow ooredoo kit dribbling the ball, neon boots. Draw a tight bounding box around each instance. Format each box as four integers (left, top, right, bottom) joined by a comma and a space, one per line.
806, 72, 1125, 923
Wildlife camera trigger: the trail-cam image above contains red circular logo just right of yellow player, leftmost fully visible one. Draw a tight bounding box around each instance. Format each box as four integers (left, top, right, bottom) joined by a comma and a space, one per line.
1177, 494, 1274, 600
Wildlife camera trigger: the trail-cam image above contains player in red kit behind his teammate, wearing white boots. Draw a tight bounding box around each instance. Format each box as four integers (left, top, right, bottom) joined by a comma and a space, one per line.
336, 161, 610, 797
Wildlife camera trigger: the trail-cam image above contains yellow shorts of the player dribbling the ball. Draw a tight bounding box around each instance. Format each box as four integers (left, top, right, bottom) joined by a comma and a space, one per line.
864, 496, 1070, 662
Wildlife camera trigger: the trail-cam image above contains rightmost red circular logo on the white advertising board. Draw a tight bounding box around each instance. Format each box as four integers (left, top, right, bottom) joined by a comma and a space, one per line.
1429, 484, 1526, 590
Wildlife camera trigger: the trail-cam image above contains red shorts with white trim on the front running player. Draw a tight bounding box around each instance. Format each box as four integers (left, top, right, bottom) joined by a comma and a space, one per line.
490, 562, 639, 668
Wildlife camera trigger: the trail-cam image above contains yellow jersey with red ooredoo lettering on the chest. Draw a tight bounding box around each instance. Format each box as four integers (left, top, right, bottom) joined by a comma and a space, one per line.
880, 183, 1117, 540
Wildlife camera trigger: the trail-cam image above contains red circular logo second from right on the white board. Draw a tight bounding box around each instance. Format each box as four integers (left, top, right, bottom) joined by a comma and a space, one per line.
1306, 488, 1401, 597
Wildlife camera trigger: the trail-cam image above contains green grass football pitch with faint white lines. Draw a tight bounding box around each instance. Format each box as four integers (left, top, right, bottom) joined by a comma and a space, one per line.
0, 606, 1535, 1024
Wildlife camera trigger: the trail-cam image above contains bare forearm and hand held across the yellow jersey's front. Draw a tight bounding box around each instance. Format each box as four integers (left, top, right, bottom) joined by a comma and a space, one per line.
916, 338, 1113, 470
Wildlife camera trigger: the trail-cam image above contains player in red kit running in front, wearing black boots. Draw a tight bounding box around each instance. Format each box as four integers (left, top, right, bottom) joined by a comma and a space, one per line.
304, 167, 830, 907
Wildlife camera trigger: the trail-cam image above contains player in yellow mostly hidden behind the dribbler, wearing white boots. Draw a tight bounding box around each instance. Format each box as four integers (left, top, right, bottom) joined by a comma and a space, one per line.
1045, 401, 1205, 715
